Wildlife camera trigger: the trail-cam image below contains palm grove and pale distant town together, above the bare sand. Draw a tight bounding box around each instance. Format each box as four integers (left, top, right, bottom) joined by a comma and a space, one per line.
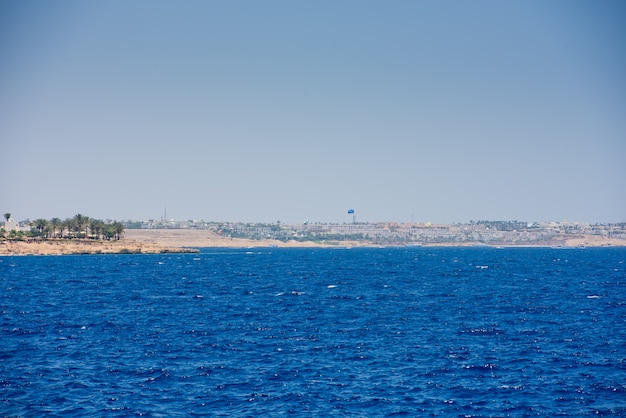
0, 213, 626, 246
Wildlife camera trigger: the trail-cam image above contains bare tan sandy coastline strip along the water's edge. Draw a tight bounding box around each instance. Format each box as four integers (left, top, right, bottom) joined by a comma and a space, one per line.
0, 229, 626, 256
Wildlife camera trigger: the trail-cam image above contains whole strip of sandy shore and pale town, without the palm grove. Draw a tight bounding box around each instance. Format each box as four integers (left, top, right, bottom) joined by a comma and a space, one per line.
0, 221, 626, 255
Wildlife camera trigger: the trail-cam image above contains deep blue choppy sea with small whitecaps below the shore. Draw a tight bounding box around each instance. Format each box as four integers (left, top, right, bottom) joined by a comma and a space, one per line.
0, 248, 626, 417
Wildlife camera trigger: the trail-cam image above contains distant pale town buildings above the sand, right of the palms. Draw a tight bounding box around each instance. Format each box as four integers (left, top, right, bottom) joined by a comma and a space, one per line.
124, 219, 626, 245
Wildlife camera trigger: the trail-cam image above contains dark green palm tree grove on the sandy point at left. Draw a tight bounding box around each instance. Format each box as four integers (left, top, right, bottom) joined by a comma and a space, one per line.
0, 213, 125, 240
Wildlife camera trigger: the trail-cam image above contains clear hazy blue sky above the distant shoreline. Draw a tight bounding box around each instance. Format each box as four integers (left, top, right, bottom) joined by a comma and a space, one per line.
0, 0, 626, 223
